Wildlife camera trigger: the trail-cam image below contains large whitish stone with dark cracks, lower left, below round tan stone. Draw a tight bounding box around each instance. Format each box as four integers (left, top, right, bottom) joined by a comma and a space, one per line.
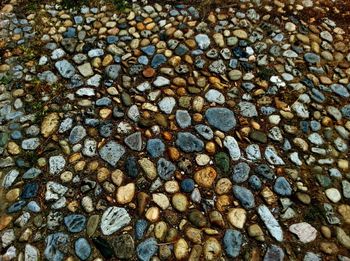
101, 207, 131, 236
